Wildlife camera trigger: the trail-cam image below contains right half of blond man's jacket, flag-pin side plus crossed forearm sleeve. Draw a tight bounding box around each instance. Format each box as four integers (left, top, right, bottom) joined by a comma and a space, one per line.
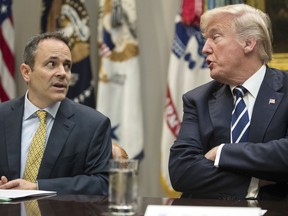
219, 77, 288, 183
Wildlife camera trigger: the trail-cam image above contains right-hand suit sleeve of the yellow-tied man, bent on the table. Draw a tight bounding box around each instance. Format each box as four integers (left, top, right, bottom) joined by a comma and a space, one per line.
38, 117, 112, 195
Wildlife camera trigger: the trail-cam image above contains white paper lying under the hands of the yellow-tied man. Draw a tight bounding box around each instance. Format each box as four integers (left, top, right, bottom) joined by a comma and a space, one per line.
0, 189, 56, 201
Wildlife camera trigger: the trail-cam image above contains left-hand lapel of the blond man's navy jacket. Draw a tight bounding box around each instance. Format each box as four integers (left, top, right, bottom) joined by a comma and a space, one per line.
208, 85, 233, 145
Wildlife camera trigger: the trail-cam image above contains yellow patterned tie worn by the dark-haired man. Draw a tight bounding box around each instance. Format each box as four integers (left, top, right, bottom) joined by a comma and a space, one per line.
23, 110, 47, 182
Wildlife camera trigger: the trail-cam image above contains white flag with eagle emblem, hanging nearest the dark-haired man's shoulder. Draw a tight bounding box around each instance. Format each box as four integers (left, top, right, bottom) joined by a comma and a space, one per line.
97, 0, 143, 159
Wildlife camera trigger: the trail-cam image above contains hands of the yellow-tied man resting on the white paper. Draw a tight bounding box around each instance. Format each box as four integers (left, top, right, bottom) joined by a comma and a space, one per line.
0, 176, 37, 190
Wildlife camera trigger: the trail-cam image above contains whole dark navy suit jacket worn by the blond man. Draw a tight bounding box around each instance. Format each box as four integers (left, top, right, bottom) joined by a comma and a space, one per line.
169, 68, 288, 199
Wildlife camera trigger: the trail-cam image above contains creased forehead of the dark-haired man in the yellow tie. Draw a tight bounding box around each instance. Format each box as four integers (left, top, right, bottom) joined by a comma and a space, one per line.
36, 38, 71, 60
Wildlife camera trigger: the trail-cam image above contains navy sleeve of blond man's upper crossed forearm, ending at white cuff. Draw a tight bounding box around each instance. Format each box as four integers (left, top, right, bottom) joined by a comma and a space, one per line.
219, 135, 288, 183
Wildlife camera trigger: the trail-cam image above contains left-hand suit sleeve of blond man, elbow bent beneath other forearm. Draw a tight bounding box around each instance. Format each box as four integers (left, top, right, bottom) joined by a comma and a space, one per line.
169, 94, 250, 199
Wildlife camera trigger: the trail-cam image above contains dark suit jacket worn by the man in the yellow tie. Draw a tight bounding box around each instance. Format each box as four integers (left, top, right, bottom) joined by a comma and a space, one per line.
0, 97, 112, 195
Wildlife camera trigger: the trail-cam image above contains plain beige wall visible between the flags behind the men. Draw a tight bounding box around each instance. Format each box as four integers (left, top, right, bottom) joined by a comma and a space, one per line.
13, 0, 179, 197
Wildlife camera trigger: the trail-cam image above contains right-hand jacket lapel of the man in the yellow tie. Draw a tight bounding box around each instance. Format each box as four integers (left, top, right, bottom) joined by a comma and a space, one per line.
38, 99, 75, 179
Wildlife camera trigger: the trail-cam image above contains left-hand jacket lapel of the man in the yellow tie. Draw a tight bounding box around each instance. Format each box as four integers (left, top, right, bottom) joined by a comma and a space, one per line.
4, 98, 24, 179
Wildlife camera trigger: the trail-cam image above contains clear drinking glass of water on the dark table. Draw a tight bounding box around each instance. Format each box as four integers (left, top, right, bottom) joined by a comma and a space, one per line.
108, 159, 138, 215
